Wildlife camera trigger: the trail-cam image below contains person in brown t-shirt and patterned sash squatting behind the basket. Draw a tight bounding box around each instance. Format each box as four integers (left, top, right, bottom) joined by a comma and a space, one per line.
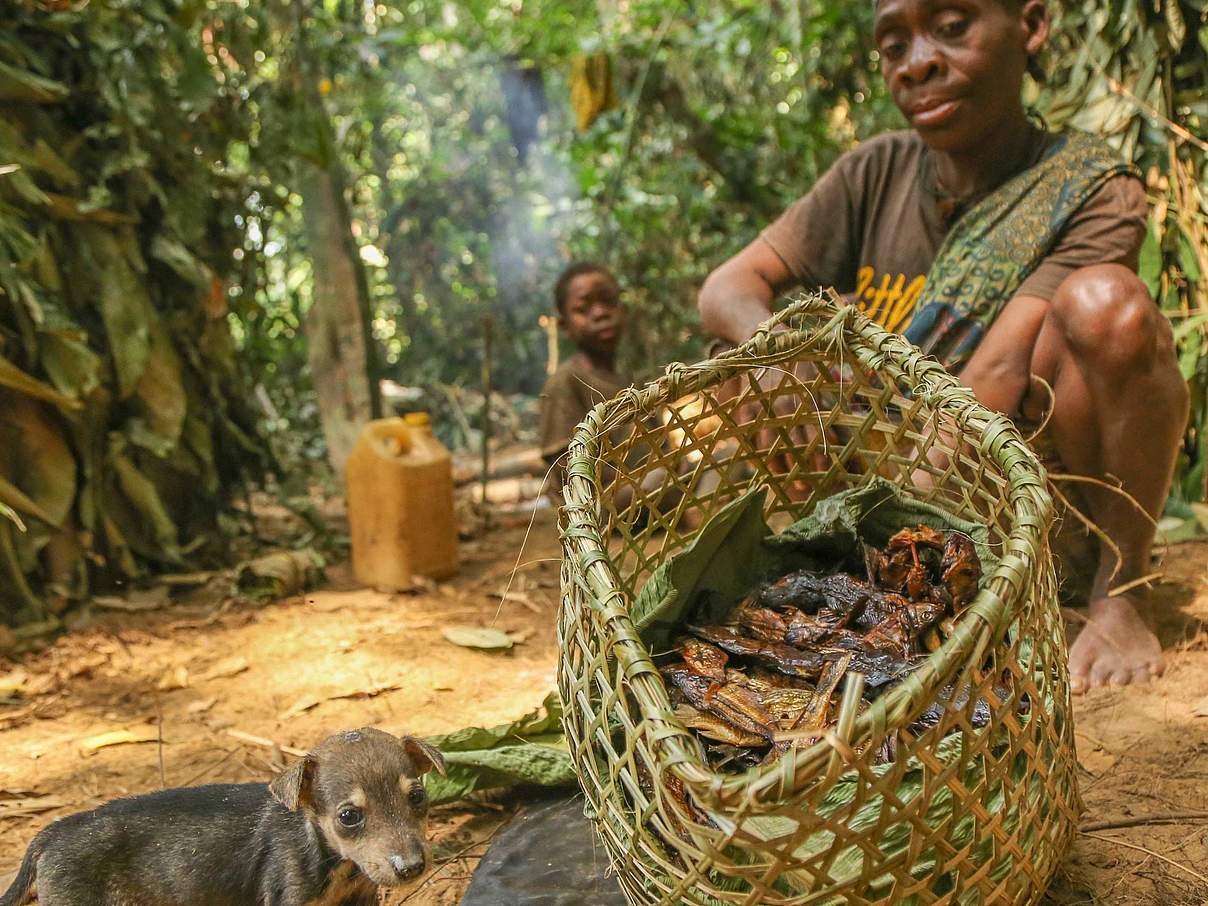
699, 0, 1187, 691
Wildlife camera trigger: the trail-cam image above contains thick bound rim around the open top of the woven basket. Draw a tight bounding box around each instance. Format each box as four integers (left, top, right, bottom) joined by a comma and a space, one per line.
559, 290, 1053, 807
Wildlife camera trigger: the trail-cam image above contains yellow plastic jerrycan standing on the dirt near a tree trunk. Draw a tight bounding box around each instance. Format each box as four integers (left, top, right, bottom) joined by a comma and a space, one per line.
344, 412, 457, 592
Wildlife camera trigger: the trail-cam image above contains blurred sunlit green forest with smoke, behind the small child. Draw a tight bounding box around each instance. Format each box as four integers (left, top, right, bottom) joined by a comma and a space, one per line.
254, 0, 900, 396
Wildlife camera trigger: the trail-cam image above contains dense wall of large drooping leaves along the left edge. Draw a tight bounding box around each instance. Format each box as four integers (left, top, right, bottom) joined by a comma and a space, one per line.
0, 0, 273, 620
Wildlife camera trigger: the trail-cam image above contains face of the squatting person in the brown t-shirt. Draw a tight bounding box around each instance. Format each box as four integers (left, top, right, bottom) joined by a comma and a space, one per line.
875, 0, 1049, 153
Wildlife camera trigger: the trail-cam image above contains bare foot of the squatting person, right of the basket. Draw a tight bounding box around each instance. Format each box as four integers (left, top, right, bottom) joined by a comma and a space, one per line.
1069, 596, 1166, 693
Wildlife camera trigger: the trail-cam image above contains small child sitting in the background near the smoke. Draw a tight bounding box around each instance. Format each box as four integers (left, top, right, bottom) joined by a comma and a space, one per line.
540, 261, 629, 496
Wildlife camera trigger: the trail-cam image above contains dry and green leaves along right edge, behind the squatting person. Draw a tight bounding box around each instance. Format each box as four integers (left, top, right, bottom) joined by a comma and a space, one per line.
1039, 0, 1208, 512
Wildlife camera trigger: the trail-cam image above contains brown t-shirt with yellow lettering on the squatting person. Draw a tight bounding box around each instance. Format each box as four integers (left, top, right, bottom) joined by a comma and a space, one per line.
762, 129, 1146, 333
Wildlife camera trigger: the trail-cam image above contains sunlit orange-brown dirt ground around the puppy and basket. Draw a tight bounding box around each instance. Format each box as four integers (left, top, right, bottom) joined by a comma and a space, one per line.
0, 507, 1208, 906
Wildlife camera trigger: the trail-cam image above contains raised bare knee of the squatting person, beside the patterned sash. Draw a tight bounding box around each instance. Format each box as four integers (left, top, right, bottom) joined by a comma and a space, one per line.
1051, 265, 1174, 372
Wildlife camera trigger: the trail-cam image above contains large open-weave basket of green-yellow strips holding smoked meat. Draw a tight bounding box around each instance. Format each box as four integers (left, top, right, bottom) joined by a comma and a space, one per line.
558, 296, 1081, 906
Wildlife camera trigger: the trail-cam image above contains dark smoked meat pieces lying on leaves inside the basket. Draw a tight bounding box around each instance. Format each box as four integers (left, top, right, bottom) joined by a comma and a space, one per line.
660, 525, 990, 769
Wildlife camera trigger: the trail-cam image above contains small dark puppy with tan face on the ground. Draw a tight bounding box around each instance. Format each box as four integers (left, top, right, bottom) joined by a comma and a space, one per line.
0, 728, 445, 906
